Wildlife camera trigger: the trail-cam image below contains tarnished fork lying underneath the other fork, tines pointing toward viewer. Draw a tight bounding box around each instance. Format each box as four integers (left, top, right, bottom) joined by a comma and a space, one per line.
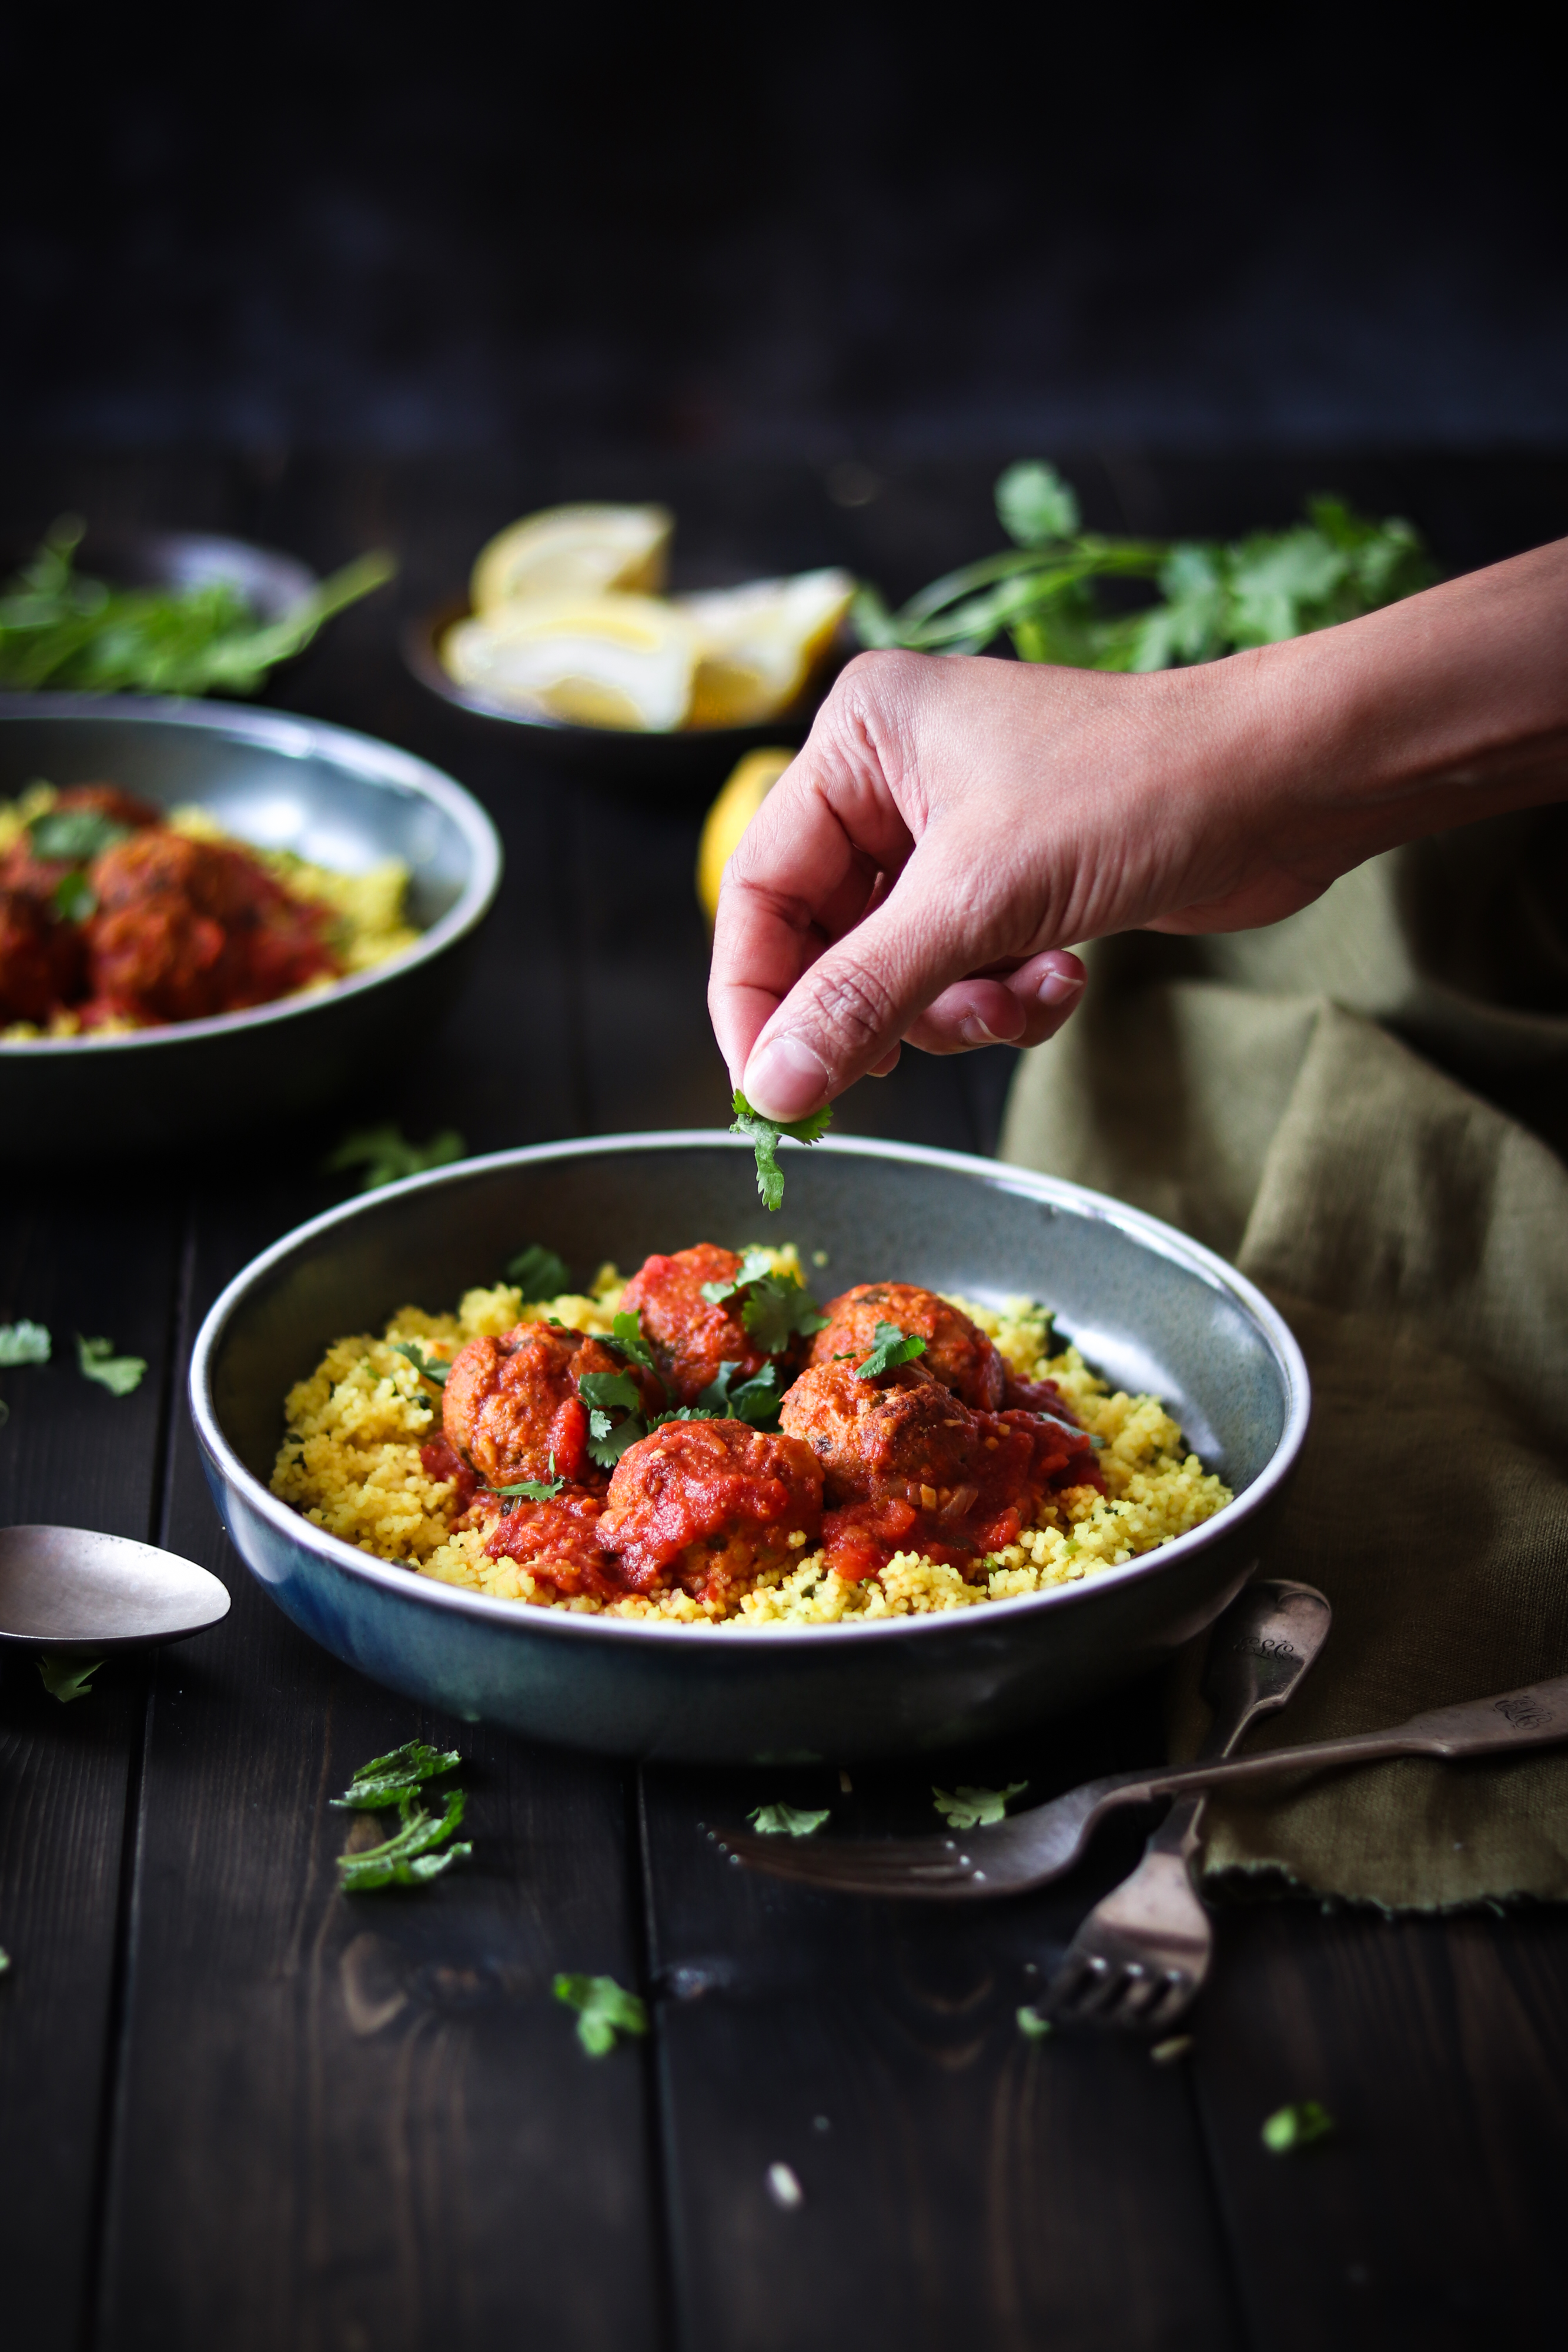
1037, 1578, 1333, 2032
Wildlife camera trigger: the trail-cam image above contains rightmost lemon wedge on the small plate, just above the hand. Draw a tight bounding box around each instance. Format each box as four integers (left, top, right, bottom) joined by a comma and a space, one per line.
675, 572, 855, 727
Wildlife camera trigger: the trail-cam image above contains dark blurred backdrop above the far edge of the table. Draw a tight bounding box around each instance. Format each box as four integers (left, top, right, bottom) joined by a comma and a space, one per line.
0, 0, 1568, 468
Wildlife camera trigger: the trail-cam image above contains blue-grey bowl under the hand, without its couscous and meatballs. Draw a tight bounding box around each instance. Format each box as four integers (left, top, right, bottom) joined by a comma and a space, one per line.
190, 1134, 1309, 1762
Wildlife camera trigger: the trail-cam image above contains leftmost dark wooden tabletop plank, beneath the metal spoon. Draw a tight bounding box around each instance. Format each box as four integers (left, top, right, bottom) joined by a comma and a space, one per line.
0, 1171, 176, 2352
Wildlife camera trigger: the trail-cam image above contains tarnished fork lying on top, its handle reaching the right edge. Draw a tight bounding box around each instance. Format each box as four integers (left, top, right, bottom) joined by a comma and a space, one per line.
715, 1675, 1568, 1903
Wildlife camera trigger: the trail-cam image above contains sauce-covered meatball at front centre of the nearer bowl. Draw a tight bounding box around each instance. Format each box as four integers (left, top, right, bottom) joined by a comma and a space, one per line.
600, 1421, 823, 1599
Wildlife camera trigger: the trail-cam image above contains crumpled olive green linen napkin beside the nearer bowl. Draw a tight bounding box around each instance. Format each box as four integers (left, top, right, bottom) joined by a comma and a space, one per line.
1001, 809, 1568, 1910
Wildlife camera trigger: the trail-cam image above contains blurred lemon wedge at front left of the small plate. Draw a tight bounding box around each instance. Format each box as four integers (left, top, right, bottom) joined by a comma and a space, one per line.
442, 595, 698, 734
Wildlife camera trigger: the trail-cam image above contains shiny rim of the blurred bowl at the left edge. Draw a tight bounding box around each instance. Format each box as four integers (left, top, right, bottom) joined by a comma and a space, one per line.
0, 694, 501, 1058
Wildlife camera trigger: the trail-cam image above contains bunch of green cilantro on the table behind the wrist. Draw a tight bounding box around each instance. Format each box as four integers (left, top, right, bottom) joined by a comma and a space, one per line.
853, 461, 1436, 670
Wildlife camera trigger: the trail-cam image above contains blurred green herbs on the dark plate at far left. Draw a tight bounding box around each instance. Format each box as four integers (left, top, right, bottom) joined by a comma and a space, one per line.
0, 515, 395, 694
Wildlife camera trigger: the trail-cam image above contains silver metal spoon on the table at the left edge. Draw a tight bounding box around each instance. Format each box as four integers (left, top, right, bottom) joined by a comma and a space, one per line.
0, 1526, 228, 1656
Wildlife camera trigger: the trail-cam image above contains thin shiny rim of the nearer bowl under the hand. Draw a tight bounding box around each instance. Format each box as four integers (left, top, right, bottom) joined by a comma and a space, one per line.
188, 1129, 1312, 1646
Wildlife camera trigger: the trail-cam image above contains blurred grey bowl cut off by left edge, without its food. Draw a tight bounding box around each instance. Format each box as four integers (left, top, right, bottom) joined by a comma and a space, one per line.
0, 694, 501, 1167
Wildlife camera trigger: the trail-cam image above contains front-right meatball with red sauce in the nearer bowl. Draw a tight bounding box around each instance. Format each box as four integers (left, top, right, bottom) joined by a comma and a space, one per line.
781, 1364, 1100, 1578
